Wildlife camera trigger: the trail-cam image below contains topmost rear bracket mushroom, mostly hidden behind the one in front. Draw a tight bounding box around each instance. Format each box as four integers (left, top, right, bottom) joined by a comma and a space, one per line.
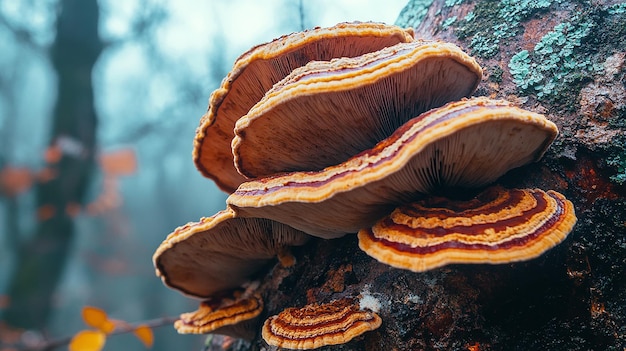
193, 23, 413, 192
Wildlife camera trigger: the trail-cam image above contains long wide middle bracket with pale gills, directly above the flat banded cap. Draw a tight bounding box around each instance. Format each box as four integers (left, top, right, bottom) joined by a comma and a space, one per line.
226, 98, 558, 238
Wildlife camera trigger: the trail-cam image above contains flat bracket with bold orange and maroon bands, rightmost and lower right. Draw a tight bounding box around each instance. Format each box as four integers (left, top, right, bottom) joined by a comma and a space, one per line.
358, 187, 576, 272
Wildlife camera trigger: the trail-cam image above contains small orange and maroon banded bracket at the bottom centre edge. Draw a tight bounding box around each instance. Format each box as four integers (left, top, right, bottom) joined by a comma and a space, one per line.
262, 298, 382, 350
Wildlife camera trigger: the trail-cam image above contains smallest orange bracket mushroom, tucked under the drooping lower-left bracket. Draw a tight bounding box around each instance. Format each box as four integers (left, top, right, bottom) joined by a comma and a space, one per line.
174, 294, 263, 339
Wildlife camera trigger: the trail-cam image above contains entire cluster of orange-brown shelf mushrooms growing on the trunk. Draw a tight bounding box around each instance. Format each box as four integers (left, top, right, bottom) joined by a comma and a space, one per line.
153, 23, 576, 349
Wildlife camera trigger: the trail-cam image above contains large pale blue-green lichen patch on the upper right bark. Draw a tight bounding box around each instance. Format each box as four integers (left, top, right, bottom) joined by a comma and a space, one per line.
508, 3, 626, 108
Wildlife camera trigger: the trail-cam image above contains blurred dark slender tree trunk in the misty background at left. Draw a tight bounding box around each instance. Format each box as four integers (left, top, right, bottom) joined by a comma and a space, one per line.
3, 0, 102, 329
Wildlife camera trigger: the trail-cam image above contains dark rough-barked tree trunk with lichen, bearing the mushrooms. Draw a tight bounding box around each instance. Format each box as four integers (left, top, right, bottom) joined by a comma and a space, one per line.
234, 0, 626, 351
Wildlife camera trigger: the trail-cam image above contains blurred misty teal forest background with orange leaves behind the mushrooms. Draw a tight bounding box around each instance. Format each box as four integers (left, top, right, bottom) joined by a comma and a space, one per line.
0, 0, 405, 351
